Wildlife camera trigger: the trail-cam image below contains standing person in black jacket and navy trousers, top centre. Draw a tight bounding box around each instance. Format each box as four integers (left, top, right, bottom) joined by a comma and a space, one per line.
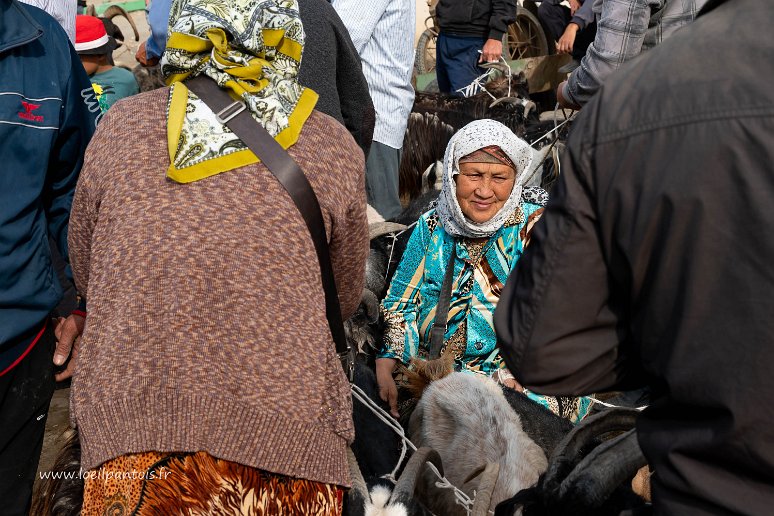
435, 0, 516, 94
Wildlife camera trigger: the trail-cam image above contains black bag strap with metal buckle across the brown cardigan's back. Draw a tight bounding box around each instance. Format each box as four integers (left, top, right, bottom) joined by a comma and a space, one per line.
185, 75, 352, 379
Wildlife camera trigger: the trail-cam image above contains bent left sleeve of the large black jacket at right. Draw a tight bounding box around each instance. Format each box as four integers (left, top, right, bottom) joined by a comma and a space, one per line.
495, 103, 644, 395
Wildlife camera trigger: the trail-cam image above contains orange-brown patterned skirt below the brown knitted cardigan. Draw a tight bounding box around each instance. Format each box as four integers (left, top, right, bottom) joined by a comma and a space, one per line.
81, 452, 343, 516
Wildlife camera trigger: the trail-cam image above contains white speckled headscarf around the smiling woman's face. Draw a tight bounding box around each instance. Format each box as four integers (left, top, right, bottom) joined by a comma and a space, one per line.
436, 119, 542, 238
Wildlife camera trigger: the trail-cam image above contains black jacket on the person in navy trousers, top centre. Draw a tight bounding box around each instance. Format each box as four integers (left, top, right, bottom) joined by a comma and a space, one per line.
435, 0, 516, 39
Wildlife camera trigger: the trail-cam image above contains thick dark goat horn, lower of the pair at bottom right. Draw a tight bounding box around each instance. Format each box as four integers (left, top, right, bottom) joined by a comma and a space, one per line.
559, 429, 647, 508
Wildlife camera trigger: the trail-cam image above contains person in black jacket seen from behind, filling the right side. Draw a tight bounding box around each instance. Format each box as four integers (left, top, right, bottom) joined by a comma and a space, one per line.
495, 0, 774, 516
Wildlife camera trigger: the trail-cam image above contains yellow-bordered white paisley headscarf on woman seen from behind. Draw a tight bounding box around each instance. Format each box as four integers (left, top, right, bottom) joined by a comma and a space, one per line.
161, 0, 317, 183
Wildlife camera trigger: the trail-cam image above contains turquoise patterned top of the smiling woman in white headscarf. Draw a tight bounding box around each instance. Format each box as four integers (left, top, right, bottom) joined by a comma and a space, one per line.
377, 188, 546, 376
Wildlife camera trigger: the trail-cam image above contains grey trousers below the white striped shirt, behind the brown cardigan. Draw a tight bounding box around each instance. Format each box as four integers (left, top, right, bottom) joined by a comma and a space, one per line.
366, 140, 403, 220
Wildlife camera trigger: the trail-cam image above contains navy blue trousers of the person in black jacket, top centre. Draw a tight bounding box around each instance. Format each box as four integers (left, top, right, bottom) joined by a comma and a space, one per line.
435, 32, 486, 96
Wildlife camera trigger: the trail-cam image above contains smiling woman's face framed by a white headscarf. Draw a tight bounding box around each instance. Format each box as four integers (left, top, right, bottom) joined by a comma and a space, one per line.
454, 162, 516, 224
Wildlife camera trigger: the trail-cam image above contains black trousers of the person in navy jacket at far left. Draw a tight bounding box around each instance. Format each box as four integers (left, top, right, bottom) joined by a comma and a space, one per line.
0, 324, 54, 516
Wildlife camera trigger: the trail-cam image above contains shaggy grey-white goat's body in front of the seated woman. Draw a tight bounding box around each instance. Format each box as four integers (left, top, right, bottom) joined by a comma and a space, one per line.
409, 373, 548, 516
